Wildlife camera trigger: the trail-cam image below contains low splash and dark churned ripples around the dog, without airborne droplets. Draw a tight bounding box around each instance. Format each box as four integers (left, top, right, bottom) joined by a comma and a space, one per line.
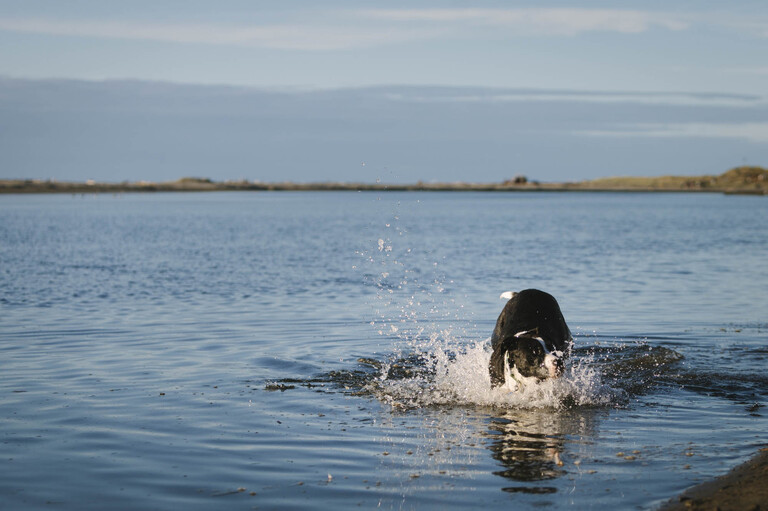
276, 338, 688, 413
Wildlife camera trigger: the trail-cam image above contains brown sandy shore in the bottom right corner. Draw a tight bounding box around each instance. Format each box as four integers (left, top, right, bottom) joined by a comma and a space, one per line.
659, 447, 768, 511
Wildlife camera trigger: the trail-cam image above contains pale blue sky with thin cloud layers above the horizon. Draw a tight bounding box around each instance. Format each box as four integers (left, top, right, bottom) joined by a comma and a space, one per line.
0, 0, 768, 182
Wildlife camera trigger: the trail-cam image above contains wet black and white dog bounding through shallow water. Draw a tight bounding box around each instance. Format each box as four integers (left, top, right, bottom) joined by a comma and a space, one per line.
488, 289, 573, 390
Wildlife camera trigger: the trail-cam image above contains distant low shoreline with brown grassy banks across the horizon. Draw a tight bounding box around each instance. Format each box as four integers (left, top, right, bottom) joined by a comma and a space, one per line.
0, 167, 768, 195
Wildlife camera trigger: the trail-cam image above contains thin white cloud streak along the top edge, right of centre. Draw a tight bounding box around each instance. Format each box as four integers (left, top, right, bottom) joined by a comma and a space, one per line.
361, 8, 689, 36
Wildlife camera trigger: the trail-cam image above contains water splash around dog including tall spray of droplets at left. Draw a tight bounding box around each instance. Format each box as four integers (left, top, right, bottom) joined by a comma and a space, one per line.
348, 215, 682, 409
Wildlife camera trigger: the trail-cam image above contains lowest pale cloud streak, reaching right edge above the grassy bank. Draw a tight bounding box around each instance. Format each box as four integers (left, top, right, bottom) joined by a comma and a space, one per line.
576, 122, 768, 143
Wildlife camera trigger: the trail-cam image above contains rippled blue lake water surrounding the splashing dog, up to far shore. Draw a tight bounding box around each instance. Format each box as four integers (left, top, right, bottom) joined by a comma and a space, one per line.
0, 192, 768, 510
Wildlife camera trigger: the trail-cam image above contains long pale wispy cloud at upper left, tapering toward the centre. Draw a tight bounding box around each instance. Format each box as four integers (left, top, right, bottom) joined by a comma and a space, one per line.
0, 18, 436, 51
